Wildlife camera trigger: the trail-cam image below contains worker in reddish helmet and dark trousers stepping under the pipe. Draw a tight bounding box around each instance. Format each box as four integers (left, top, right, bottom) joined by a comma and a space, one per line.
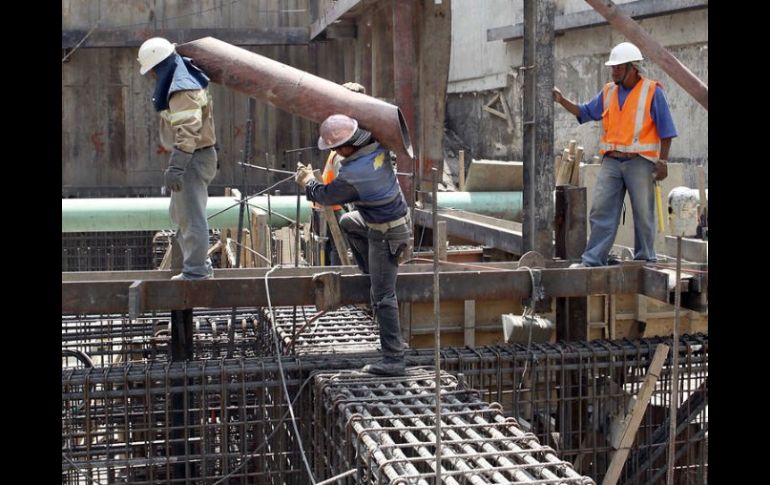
295, 114, 411, 375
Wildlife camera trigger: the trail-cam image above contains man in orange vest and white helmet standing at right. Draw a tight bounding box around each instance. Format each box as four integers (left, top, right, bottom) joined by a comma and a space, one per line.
553, 42, 677, 267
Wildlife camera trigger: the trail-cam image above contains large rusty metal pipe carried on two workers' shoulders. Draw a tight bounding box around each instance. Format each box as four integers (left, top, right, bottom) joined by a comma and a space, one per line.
176, 37, 414, 158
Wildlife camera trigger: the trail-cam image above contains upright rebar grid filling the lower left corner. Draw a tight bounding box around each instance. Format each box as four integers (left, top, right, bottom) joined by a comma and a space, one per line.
62, 359, 311, 484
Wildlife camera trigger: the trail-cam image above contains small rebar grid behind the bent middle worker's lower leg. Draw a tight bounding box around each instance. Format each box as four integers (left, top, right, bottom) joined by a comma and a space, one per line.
272, 306, 380, 355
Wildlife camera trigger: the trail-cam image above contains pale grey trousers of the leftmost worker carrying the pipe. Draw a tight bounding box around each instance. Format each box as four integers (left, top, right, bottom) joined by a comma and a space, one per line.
168, 147, 217, 278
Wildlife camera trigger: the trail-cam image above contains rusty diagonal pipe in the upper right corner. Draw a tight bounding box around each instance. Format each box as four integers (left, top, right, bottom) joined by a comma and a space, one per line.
586, 0, 709, 111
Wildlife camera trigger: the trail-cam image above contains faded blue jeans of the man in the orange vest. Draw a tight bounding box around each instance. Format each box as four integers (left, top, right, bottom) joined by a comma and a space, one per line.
582, 156, 657, 266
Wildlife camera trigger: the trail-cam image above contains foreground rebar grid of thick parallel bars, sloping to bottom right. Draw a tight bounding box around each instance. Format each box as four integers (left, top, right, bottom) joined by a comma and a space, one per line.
313, 369, 594, 485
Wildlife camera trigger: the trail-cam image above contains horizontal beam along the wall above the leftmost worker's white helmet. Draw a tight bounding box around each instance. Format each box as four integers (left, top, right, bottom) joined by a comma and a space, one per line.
61, 27, 310, 49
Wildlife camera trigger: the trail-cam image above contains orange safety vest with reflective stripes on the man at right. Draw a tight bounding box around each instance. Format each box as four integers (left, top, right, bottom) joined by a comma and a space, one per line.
599, 78, 660, 162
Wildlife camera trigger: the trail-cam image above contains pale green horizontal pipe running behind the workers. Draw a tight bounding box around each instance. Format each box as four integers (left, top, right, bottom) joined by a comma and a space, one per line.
61, 192, 521, 232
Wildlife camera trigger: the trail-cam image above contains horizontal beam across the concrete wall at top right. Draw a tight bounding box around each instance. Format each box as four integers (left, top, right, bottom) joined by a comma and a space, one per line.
487, 0, 708, 42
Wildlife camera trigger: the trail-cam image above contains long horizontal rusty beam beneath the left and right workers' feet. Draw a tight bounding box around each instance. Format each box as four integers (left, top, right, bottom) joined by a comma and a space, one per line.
62, 265, 667, 315
